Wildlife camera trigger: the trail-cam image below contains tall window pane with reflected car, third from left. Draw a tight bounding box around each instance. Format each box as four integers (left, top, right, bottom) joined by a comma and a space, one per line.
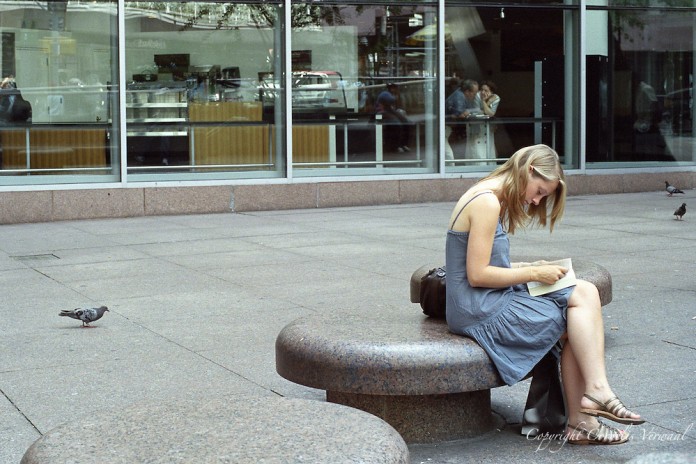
291, 2, 437, 176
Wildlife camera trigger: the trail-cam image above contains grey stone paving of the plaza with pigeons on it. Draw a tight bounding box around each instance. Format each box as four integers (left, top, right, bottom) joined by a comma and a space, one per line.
0, 190, 696, 464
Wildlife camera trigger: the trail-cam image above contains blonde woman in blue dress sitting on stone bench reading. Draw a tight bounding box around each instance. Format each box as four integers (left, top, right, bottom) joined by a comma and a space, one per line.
446, 145, 644, 445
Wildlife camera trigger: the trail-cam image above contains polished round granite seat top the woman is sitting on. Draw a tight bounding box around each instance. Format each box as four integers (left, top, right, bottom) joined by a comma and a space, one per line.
276, 306, 503, 395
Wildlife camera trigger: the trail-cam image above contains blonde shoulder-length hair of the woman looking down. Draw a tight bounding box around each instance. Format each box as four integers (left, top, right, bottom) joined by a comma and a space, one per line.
481, 144, 567, 234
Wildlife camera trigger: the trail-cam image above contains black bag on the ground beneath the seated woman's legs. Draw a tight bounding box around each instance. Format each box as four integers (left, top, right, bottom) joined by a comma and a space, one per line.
522, 348, 567, 437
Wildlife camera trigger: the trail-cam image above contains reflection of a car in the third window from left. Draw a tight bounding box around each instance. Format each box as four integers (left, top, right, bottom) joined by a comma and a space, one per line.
292, 71, 346, 112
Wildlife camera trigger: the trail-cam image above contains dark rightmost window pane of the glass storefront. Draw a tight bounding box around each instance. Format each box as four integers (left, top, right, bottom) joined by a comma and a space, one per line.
587, 8, 696, 167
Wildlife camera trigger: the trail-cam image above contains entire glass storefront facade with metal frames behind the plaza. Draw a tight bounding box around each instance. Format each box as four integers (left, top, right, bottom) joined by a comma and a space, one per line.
0, 0, 696, 188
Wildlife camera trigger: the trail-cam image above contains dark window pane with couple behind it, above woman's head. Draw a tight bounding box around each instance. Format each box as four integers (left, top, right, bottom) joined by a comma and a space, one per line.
444, 4, 579, 171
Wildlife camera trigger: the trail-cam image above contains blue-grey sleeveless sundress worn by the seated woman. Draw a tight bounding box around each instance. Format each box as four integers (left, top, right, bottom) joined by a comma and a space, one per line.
445, 195, 575, 385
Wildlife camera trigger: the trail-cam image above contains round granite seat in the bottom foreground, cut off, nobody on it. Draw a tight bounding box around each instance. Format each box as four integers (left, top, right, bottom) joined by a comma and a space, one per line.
21, 396, 409, 464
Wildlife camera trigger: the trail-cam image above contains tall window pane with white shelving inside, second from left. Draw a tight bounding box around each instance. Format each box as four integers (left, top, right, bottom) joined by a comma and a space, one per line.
126, 2, 285, 180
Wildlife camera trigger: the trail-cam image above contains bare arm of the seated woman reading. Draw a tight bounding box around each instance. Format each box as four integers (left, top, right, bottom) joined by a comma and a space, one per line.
460, 195, 568, 288
